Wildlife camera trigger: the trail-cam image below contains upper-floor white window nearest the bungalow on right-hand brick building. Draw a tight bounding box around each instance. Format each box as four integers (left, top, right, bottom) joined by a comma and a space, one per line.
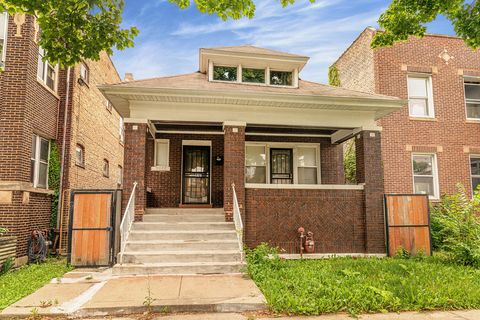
408, 76, 435, 118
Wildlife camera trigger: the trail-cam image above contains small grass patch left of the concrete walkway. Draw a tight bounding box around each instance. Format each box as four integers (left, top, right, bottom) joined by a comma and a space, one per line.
0, 259, 72, 311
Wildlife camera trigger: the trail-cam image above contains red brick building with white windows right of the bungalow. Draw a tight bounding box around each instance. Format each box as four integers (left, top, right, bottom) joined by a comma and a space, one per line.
334, 28, 480, 200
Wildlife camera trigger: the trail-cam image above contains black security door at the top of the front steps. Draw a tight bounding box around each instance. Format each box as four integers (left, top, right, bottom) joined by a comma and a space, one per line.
182, 146, 210, 204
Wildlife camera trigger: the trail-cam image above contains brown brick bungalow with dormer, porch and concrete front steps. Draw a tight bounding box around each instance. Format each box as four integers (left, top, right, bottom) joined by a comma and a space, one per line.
100, 46, 405, 273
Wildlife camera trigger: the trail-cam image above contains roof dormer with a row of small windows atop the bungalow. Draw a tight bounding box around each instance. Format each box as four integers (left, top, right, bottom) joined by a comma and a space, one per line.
200, 45, 309, 88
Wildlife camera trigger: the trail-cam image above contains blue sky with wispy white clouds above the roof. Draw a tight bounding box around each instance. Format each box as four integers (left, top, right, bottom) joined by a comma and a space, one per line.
113, 0, 454, 83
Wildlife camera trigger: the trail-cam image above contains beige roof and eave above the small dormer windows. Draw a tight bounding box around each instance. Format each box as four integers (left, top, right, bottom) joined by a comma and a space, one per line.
199, 48, 310, 73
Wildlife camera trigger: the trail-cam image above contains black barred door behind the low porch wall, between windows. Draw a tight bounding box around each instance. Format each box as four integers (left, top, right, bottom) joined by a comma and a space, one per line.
270, 149, 293, 184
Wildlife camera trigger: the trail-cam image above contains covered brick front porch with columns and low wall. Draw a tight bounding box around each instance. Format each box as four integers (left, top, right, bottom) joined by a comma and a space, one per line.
124, 120, 385, 253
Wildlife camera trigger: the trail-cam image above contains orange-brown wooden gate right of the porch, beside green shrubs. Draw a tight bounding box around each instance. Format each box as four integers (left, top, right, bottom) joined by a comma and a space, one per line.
385, 194, 432, 256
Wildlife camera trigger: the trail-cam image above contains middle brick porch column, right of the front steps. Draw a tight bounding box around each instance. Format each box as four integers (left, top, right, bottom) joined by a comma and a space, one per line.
223, 121, 246, 221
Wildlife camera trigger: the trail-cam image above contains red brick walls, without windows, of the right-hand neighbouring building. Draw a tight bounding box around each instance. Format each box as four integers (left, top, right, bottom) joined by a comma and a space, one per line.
335, 29, 480, 200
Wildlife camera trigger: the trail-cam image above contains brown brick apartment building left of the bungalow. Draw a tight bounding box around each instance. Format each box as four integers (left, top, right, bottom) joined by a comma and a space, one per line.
0, 13, 123, 263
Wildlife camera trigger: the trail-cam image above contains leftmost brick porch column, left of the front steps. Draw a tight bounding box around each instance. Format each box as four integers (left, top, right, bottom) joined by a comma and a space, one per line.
122, 123, 148, 220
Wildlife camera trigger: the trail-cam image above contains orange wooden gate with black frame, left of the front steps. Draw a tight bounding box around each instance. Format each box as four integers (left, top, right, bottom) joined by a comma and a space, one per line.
68, 190, 116, 267
